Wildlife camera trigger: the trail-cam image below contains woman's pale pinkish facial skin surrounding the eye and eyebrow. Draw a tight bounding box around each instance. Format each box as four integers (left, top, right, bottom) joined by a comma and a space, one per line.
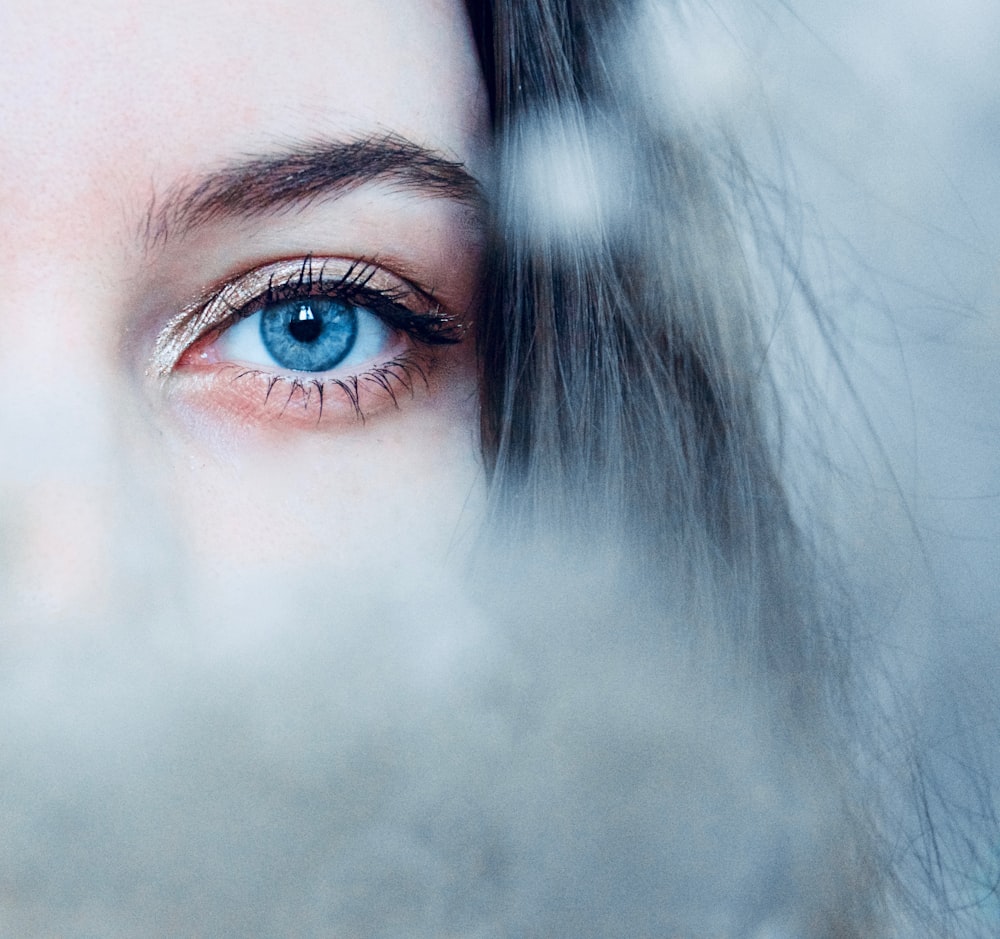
0, 0, 486, 638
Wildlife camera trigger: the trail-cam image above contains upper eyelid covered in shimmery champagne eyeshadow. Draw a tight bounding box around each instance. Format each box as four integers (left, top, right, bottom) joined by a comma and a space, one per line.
151, 255, 436, 378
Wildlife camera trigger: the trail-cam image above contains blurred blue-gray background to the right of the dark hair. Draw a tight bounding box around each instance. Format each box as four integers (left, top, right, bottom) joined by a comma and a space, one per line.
728, 0, 1000, 935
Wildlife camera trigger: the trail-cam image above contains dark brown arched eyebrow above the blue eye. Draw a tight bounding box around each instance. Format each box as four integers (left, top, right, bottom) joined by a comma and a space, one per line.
143, 134, 484, 248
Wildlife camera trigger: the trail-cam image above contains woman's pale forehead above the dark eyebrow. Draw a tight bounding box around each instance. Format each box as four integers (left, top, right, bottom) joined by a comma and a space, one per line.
0, 0, 484, 224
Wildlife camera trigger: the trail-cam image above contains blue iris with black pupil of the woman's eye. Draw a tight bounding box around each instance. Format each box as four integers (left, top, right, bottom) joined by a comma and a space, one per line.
260, 297, 358, 372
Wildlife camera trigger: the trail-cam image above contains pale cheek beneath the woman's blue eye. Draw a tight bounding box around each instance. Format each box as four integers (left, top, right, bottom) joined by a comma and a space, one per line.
153, 360, 485, 628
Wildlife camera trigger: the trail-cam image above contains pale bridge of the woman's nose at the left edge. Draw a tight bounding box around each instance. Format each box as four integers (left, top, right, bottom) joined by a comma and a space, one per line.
0, 246, 139, 630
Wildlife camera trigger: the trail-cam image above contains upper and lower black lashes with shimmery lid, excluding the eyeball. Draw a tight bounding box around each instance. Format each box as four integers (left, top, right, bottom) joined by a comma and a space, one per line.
153, 255, 466, 422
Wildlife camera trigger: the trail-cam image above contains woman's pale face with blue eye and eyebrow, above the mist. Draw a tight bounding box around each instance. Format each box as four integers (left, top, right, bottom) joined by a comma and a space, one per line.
0, 0, 487, 645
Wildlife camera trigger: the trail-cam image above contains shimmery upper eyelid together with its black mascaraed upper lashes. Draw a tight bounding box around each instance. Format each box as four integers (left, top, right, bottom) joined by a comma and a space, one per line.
153, 255, 466, 376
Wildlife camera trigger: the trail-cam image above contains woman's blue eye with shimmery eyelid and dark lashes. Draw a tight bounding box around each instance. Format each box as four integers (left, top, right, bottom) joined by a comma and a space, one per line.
153, 256, 464, 428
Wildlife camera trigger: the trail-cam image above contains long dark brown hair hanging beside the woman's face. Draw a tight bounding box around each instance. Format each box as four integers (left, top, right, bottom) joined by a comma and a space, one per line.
467, 0, 892, 937
